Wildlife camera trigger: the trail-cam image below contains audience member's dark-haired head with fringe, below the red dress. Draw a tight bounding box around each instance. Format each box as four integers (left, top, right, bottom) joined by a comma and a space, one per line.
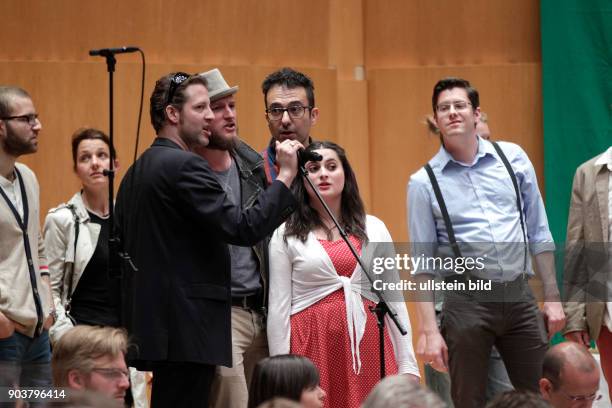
249, 354, 325, 408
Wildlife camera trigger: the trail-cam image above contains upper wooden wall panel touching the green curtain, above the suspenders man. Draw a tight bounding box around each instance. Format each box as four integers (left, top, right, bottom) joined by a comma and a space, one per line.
364, 0, 541, 69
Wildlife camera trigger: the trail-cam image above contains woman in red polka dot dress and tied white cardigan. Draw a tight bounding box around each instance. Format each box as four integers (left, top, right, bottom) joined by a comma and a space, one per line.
268, 142, 419, 408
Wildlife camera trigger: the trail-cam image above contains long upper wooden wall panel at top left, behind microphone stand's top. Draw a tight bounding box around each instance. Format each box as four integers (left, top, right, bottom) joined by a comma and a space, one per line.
0, 0, 329, 67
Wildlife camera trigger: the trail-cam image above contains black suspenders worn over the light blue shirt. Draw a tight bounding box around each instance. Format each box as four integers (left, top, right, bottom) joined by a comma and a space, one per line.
424, 142, 528, 273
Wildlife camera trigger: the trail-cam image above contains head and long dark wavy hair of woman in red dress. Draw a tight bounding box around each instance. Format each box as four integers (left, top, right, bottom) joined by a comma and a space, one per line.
285, 141, 367, 242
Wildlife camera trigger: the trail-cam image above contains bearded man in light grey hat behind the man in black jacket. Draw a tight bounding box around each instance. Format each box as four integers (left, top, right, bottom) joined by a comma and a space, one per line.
195, 68, 268, 408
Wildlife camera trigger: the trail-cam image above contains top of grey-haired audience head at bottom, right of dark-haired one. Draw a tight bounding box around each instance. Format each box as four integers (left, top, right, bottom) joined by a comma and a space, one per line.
361, 375, 446, 408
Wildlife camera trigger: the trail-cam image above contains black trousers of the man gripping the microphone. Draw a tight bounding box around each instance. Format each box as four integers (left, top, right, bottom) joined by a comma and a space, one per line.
151, 362, 215, 408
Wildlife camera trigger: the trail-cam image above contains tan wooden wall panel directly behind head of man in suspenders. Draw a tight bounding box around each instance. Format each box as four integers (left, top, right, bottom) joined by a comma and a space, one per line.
368, 64, 543, 241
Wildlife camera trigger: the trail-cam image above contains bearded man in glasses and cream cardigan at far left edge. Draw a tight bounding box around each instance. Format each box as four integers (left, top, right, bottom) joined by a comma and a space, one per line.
0, 86, 54, 387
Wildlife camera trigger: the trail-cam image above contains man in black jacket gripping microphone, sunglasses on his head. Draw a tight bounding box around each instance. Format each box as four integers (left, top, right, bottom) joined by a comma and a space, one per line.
115, 72, 302, 407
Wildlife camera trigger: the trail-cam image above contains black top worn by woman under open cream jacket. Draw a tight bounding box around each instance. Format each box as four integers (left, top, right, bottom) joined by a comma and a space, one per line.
70, 211, 120, 326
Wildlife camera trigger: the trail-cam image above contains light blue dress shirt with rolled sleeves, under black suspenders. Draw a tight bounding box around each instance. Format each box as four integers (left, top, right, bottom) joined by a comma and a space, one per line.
407, 138, 555, 281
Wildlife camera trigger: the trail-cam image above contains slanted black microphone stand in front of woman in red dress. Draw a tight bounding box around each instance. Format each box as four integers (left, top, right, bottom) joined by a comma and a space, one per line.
298, 157, 408, 380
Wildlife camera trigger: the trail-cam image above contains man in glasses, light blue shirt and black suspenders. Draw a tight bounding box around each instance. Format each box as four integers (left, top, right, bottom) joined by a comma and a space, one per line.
408, 78, 565, 408
